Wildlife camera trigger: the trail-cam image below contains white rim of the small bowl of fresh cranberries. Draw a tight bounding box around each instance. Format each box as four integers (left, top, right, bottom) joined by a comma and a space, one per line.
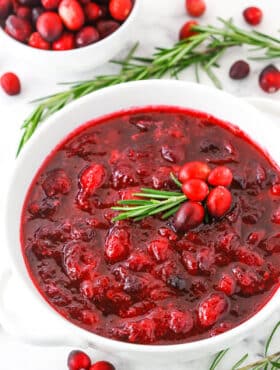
0, 0, 142, 59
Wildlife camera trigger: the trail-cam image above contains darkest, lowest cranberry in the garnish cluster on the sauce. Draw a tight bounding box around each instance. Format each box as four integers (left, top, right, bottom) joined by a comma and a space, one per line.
173, 201, 205, 232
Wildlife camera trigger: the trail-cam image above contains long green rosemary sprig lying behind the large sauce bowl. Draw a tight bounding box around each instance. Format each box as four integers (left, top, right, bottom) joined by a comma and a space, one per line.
17, 19, 280, 155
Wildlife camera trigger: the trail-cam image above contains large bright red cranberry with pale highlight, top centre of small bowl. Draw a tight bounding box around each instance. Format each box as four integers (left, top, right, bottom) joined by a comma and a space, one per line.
58, 0, 85, 31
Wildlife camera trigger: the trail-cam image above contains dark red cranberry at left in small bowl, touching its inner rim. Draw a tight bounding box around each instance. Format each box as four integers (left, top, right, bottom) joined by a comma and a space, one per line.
5, 15, 32, 42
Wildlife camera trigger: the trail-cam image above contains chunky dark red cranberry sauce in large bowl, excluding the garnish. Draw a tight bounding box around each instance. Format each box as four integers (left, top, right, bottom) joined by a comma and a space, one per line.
21, 107, 280, 344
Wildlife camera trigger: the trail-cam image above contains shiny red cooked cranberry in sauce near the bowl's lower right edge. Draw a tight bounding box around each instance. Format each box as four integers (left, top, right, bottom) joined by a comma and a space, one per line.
198, 293, 229, 327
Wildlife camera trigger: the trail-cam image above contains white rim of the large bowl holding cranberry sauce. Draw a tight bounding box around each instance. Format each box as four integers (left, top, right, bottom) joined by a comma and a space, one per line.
5, 79, 280, 353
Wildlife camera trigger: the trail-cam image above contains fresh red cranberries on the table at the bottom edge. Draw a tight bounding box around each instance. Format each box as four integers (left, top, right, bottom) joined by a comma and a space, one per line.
67, 351, 115, 370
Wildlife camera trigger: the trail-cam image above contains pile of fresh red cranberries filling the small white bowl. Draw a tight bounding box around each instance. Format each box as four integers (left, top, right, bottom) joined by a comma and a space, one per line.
0, 0, 133, 50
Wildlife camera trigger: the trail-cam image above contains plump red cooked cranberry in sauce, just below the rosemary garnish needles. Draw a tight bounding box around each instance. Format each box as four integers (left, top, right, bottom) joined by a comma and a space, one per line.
104, 227, 131, 263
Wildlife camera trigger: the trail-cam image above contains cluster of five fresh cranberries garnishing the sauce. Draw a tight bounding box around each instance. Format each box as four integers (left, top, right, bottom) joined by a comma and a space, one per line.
174, 162, 233, 231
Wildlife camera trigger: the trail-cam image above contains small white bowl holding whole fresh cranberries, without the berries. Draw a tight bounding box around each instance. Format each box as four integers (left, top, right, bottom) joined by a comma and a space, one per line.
0, 0, 142, 78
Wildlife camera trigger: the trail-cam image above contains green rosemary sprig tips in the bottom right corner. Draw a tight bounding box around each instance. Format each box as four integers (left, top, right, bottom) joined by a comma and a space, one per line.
209, 321, 280, 370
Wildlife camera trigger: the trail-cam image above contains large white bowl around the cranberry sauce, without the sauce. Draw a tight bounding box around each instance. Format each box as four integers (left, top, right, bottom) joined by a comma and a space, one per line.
0, 80, 280, 368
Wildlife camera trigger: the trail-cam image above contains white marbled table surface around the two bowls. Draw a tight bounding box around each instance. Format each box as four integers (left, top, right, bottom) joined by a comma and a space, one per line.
0, 0, 280, 370
